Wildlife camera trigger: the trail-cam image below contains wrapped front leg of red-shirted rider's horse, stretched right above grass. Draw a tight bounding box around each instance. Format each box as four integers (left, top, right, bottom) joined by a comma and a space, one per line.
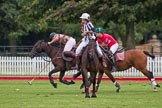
105, 70, 120, 92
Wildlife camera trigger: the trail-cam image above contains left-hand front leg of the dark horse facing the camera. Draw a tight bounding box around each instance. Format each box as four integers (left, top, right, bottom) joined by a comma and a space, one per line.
82, 69, 90, 98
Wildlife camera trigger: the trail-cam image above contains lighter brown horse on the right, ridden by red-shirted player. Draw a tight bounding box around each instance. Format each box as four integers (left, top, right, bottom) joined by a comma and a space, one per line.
97, 49, 160, 91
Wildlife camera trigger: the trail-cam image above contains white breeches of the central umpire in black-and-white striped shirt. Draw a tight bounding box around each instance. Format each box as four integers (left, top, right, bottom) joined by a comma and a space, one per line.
75, 38, 103, 56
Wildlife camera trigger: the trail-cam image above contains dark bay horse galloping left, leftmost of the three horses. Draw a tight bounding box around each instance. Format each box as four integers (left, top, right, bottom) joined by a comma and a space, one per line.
29, 40, 75, 88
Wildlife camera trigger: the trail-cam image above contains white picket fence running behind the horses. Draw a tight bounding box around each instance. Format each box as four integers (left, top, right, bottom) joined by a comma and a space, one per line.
0, 56, 162, 77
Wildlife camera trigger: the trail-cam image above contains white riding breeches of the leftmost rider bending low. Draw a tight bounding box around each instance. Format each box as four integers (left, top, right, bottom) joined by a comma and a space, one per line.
64, 37, 76, 51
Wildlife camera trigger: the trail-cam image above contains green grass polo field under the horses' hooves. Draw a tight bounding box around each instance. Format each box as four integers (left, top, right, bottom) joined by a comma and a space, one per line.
0, 81, 162, 108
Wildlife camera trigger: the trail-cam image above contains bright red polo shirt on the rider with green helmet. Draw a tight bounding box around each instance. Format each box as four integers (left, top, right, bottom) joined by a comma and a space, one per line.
97, 33, 117, 48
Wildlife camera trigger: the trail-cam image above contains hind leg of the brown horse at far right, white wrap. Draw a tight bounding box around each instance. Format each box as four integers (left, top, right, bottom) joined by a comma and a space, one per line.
141, 69, 160, 91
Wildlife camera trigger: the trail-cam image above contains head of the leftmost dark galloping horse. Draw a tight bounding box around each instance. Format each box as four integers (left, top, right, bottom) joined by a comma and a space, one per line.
29, 40, 46, 58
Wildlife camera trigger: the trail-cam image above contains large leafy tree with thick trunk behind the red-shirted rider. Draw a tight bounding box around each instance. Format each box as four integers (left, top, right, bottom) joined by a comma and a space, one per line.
47, 0, 162, 49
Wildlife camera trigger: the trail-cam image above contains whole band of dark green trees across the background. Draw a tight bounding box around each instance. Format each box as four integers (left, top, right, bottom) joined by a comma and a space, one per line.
0, 0, 162, 49
